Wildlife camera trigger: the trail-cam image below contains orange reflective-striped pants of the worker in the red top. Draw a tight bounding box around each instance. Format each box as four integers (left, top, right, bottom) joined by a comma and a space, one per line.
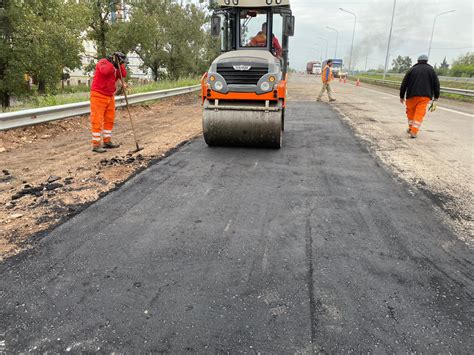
91, 91, 115, 146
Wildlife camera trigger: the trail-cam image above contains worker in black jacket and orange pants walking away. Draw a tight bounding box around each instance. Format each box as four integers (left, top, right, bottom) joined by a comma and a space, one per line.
400, 55, 440, 138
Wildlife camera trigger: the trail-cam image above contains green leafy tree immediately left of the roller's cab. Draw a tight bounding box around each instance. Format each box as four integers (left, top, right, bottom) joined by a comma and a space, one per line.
123, 0, 215, 80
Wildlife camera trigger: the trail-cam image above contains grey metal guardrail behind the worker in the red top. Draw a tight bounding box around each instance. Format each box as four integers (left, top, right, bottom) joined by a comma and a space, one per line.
0, 85, 201, 131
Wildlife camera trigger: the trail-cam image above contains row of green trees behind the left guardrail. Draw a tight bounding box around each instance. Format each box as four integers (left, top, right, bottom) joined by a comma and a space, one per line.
0, 0, 218, 107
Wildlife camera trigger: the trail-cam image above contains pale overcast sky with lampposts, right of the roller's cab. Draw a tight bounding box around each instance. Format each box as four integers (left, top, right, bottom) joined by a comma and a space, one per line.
290, 0, 474, 70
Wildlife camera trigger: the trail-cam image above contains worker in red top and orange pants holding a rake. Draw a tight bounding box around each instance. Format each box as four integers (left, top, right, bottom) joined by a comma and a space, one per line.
91, 52, 128, 153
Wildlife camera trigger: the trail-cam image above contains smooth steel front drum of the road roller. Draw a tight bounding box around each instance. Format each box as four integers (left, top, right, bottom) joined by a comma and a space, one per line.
203, 109, 283, 148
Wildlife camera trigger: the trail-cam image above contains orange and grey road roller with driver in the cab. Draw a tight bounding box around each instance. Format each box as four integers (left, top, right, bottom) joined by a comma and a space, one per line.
201, 0, 295, 148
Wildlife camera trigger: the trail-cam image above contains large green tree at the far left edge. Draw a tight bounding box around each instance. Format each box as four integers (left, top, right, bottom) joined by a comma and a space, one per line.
0, 0, 85, 107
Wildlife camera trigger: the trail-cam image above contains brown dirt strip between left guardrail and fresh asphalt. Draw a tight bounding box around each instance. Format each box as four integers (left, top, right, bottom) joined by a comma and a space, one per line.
0, 94, 202, 260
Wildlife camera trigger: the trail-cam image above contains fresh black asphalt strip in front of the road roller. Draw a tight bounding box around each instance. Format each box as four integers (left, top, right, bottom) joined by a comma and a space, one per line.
0, 102, 474, 354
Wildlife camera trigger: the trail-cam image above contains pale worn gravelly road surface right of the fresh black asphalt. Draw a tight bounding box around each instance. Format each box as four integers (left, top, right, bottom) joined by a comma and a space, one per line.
290, 75, 474, 247
